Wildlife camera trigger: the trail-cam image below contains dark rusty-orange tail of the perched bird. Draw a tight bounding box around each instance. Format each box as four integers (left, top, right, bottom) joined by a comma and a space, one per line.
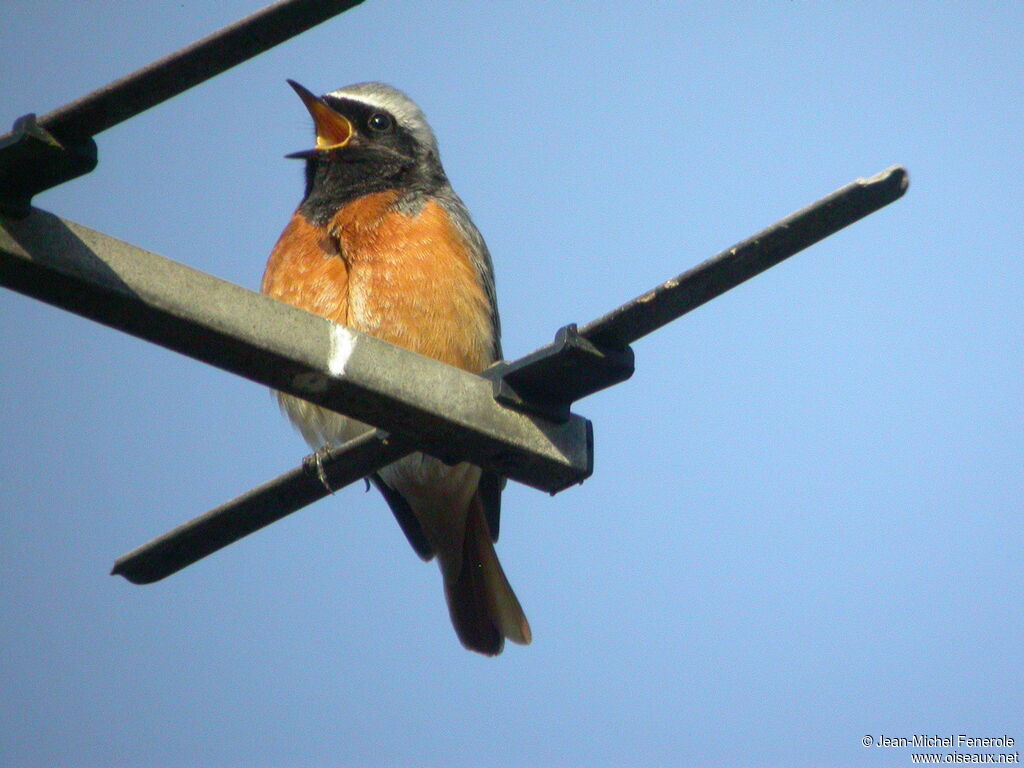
444, 495, 531, 656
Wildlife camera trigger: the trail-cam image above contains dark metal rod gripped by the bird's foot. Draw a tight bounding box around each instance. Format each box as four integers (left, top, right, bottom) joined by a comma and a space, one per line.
111, 430, 403, 584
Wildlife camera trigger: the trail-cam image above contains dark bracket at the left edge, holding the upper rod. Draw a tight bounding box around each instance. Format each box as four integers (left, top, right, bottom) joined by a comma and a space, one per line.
0, 114, 98, 218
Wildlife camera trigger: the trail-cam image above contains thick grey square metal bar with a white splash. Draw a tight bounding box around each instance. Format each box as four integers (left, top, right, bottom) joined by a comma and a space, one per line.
0, 209, 593, 493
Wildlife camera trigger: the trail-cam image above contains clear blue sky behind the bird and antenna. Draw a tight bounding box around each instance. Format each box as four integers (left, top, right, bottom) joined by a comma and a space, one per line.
0, 0, 1024, 768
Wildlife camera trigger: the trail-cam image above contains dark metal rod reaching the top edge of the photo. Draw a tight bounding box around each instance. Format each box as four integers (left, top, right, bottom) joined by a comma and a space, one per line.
39, 0, 362, 139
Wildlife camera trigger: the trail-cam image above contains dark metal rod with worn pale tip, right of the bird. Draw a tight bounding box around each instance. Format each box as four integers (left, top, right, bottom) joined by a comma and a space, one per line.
580, 166, 909, 348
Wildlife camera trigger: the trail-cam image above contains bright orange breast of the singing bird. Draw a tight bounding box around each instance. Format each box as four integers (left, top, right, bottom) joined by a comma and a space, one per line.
262, 191, 494, 372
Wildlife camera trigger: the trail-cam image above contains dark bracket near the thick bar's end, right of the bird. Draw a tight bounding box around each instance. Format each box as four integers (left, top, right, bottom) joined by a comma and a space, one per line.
480, 323, 633, 424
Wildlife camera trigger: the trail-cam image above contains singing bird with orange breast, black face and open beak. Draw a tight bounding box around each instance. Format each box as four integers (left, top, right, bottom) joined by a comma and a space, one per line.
261, 80, 531, 656
